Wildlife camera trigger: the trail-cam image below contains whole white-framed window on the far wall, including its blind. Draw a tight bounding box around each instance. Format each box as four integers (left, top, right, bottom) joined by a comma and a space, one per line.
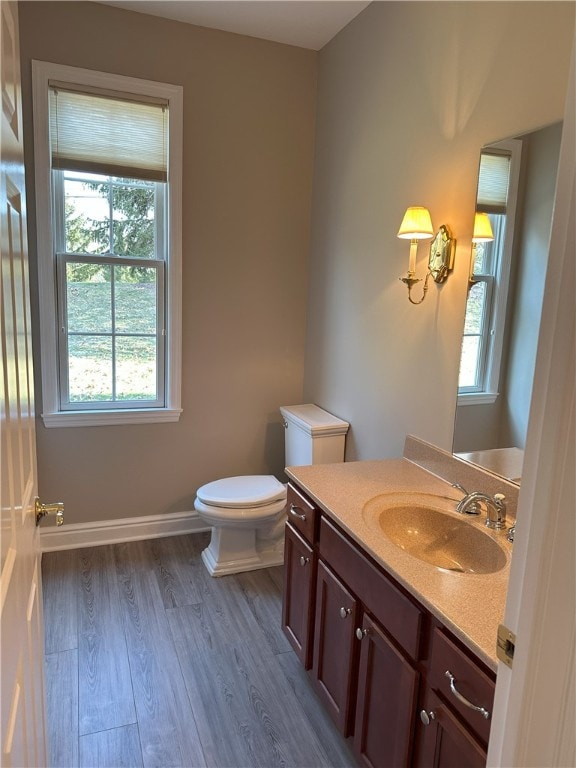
33, 62, 182, 426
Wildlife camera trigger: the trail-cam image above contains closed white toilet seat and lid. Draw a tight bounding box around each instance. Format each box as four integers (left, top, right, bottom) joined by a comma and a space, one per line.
196, 475, 286, 510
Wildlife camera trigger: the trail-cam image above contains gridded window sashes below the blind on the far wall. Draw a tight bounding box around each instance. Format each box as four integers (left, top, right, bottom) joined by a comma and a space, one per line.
52, 170, 166, 411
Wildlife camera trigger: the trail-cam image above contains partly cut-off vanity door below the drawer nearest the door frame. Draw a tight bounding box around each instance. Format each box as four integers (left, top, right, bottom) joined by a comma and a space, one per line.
415, 690, 486, 768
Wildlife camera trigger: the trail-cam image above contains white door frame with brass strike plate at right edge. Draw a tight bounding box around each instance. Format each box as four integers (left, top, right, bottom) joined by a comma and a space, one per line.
488, 37, 576, 768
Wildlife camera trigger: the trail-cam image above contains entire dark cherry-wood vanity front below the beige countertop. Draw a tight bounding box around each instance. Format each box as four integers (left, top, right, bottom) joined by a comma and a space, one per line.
282, 484, 495, 768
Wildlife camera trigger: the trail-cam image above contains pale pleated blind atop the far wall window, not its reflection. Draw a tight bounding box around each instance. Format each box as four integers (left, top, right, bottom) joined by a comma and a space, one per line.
50, 84, 168, 181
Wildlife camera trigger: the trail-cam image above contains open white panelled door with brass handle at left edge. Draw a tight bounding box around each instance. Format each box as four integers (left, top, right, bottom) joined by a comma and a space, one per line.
0, 2, 46, 768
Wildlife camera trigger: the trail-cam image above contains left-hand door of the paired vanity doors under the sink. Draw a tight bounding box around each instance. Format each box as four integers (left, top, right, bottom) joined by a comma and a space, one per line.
312, 560, 358, 736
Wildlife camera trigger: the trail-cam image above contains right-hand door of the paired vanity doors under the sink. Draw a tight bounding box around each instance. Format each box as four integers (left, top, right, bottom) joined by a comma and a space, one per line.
354, 614, 419, 768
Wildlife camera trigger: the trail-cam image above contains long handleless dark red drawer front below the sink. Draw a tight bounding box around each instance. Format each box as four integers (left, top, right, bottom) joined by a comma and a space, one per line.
320, 517, 424, 659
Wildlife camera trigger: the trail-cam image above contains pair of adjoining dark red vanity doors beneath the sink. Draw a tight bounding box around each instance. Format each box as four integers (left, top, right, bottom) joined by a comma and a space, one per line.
312, 560, 419, 767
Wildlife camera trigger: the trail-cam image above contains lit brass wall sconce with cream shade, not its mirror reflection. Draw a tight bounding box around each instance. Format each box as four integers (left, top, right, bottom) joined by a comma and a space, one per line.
398, 206, 456, 304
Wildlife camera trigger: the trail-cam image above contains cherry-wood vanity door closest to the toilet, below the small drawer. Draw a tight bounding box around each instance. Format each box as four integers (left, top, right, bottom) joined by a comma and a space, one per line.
282, 525, 316, 669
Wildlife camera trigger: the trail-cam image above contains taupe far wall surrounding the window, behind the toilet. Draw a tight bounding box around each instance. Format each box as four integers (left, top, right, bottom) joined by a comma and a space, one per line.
19, 2, 318, 523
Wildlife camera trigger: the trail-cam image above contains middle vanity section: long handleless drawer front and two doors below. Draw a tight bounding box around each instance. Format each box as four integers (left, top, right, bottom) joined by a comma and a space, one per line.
312, 517, 423, 768
